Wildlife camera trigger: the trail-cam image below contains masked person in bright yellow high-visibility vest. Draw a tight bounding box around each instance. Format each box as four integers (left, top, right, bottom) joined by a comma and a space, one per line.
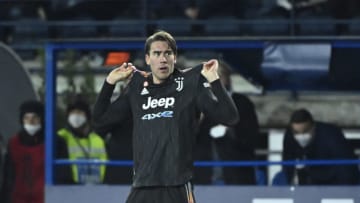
56, 100, 108, 184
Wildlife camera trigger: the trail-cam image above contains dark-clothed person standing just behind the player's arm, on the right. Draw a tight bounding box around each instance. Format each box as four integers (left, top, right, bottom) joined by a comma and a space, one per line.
194, 61, 259, 185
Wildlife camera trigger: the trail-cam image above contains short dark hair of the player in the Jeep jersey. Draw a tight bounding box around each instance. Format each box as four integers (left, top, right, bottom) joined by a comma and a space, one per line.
145, 30, 177, 55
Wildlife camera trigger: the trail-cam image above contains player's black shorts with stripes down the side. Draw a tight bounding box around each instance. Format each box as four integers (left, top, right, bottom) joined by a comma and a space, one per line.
126, 183, 195, 203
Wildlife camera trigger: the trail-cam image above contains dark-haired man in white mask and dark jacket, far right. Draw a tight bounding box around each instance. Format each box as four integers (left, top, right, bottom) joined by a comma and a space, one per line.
282, 109, 360, 185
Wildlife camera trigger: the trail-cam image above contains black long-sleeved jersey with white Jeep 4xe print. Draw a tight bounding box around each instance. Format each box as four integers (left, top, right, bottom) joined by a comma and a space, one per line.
94, 65, 238, 187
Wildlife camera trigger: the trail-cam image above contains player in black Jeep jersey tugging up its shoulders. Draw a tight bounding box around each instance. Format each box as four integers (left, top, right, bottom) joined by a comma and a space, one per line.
94, 31, 238, 203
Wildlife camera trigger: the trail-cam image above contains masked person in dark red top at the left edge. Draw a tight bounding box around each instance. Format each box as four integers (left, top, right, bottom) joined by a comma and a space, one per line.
0, 100, 45, 203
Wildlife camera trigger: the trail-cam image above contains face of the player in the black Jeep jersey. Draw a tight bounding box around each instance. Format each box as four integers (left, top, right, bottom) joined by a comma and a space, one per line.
145, 41, 176, 84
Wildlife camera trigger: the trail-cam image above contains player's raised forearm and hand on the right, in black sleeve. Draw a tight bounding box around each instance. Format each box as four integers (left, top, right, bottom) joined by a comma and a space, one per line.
197, 59, 239, 125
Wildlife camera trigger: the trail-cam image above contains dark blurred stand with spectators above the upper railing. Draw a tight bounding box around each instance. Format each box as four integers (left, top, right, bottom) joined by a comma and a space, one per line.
0, 0, 359, 20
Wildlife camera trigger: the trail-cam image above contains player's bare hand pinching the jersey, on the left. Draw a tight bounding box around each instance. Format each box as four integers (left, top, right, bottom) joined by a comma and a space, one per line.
106, 63, 136, 85
